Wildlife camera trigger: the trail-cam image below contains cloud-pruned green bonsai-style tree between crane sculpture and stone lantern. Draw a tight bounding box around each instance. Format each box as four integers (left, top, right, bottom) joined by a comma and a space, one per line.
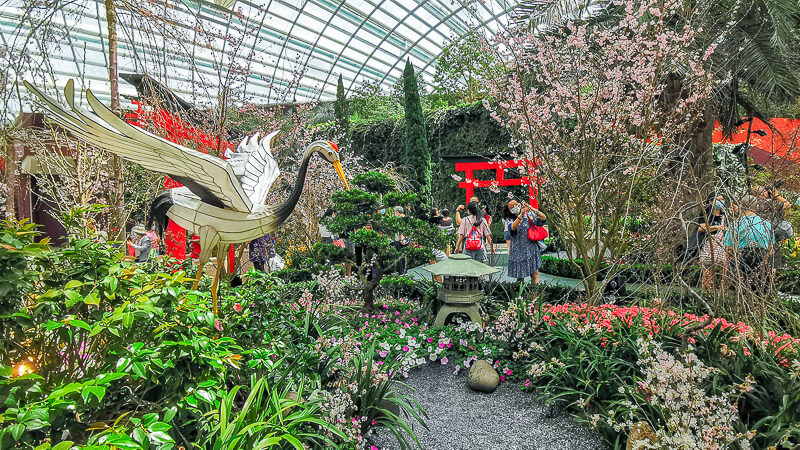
314, 172, 447, 310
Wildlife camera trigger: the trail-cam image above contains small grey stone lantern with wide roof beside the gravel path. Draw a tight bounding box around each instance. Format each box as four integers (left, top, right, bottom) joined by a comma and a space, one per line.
423, 253, 499, 328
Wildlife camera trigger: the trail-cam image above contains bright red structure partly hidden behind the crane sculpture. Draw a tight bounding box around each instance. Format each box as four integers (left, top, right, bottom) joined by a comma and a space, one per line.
125, 100, 235, 273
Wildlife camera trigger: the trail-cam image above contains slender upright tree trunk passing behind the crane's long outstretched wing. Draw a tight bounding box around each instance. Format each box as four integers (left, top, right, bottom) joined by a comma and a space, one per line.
105, 0, 126, 240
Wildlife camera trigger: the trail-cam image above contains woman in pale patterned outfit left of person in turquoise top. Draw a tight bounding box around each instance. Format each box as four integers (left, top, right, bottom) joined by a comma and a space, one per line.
697, 196, 728, 291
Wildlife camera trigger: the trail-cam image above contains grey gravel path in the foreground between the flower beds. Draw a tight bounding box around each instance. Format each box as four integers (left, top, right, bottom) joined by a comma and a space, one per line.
372, 362, 607, 450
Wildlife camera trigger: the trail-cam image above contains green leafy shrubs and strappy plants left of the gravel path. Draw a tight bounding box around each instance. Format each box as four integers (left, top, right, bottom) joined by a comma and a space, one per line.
0, 223, 423, 449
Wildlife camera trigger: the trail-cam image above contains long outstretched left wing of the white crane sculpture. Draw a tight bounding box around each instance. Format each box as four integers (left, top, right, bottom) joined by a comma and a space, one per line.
25, 80, 256, 212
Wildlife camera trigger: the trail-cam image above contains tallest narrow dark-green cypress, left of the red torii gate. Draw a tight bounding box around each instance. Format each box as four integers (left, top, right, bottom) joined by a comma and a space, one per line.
403, 60, 431, 203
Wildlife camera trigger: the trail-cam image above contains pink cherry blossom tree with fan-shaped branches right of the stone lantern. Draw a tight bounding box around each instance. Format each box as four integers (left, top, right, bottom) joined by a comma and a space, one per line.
484, 0, 714, 298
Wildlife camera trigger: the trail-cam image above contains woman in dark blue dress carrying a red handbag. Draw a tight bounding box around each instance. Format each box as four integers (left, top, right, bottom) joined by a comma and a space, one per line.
506, 200, 547, 284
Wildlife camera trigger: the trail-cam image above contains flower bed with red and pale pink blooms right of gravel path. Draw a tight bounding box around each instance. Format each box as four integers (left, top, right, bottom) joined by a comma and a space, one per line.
506, 304, 800, 448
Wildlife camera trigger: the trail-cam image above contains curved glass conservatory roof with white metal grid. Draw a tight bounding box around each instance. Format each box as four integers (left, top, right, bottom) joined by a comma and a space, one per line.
0, 0, 518, 108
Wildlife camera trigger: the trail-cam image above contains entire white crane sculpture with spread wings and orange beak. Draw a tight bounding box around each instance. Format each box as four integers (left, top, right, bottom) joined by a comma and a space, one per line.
25, 80, 349, 314
